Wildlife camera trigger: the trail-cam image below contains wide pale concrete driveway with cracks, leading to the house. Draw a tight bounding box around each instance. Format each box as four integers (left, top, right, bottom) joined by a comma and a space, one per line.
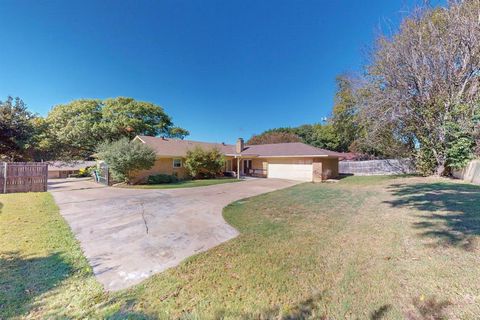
49, 179, 299, 290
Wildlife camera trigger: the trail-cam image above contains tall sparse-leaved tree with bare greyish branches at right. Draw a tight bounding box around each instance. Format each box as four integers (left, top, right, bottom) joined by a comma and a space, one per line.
360, 0, 480, 175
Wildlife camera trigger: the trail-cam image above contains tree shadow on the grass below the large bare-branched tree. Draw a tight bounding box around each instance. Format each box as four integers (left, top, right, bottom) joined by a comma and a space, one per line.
387, 183, 480, 250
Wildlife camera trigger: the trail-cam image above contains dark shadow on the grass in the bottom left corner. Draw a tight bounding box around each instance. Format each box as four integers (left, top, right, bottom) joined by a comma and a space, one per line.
0, 252, 71, 319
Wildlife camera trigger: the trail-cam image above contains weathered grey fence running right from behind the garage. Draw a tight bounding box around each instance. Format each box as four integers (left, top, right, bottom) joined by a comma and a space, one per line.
339, 159, 415, 176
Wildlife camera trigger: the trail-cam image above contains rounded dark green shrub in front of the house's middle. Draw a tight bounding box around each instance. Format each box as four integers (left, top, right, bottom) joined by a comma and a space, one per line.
185, 147, 225, 179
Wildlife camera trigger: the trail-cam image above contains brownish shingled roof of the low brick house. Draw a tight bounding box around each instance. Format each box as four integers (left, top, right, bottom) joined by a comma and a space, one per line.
136, 136, 338, 157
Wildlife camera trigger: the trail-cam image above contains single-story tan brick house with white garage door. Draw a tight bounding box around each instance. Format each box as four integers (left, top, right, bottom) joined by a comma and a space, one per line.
134, 136, 338, 183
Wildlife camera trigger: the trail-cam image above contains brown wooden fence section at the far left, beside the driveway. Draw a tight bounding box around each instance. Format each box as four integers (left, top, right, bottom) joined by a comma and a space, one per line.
0, 162, 48, 193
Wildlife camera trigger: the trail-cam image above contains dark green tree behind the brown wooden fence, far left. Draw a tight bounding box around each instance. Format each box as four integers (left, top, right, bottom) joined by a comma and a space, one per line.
0, 97, 36, 161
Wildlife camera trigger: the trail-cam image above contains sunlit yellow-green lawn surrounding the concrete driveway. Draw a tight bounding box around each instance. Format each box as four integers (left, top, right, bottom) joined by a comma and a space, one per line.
0, 177, 480, 319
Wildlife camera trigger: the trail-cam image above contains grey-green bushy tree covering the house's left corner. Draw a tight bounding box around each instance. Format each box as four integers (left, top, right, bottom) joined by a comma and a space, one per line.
96, 137, 156, 183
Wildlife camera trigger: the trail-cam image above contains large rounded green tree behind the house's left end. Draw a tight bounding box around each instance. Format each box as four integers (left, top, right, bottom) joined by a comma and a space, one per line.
38, 97, 188, 159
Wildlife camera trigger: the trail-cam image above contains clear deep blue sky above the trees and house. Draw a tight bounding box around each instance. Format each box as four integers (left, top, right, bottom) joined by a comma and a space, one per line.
0, 0, 442, 142
